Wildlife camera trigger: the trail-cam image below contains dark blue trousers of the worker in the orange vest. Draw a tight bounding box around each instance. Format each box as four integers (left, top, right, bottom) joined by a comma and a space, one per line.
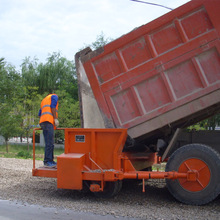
40, 121, 54, 164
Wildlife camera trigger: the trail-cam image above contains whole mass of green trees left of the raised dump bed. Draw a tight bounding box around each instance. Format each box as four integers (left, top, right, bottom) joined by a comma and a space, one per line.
0, 53, 80, 144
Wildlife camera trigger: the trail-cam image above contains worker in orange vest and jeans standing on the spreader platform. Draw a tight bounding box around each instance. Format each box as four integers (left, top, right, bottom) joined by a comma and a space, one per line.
38, 93, 59, 168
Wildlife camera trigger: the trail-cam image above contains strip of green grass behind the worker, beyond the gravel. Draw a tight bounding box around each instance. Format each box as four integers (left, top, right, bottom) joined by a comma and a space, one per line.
0, 145, 64, 160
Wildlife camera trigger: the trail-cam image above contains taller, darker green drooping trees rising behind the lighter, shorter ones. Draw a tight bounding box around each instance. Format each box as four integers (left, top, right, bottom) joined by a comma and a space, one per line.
21, 53, 78, 99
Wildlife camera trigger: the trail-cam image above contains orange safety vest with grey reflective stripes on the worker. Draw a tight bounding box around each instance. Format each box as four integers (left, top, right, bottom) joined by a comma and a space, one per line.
39, 94, 58, 125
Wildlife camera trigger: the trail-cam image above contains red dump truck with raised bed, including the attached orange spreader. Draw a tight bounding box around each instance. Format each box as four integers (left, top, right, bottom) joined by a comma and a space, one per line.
32, 0, 220, 205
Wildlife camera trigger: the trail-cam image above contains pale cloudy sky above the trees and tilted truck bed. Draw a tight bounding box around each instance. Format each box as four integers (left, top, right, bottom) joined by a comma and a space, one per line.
0, 0, 189, 70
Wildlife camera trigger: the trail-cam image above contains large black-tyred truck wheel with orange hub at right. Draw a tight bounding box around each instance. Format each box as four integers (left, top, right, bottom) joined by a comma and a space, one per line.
166, 144, 220, 205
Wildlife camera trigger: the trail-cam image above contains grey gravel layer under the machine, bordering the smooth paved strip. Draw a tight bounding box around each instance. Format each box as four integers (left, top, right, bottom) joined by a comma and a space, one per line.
0, 158, 220, 219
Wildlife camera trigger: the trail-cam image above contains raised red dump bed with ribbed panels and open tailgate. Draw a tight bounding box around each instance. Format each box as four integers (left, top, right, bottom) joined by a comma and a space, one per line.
76, 0, 220, 144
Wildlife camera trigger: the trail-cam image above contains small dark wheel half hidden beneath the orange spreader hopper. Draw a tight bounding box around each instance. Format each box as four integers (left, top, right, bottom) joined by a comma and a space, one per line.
93, 180, 122, 198
